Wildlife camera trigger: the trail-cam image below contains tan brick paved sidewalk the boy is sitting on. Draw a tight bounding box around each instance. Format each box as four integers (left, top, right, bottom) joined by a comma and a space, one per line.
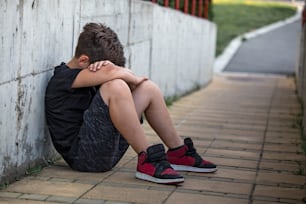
0, 74, 306, 204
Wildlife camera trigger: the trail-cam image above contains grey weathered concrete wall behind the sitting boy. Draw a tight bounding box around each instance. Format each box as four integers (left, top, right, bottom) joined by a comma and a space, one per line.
0, 0, 216, 184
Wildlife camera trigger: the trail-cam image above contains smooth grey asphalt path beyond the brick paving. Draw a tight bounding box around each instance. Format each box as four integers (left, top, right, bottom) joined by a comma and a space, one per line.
225, 20, 301, 75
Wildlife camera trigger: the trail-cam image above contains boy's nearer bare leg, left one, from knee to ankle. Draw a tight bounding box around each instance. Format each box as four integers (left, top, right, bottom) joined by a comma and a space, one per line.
100, 79, 150, 153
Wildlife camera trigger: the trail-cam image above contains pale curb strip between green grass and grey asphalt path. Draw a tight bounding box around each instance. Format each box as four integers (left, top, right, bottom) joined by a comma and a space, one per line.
214, 6, 302, 73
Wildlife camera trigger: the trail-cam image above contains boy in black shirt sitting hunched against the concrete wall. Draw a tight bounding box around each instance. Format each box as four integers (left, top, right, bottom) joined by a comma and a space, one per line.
45, 23, 217, 184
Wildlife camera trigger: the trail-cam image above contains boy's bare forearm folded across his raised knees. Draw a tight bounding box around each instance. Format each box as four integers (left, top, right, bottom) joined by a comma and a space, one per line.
72, 63, 147, 88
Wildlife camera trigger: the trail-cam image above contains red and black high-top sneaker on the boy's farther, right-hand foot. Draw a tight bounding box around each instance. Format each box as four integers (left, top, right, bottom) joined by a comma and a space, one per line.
167, 138, 217, 172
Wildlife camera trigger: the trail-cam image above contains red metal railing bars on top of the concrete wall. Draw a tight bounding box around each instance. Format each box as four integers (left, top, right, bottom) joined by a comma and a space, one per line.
151, 0, 212, 19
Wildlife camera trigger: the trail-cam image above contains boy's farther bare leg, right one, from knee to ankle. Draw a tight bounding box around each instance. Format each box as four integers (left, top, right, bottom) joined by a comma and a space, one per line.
132, 80, 183, 148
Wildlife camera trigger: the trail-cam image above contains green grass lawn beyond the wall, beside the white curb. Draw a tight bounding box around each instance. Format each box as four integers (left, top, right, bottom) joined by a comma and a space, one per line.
213, 0, 296, 56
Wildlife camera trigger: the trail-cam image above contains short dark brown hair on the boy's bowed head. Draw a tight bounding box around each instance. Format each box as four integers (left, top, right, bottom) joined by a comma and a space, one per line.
75, 23, 125, 67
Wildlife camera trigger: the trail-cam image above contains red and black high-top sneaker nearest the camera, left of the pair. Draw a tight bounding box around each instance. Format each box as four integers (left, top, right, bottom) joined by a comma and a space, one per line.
136, 144, 184, 184
